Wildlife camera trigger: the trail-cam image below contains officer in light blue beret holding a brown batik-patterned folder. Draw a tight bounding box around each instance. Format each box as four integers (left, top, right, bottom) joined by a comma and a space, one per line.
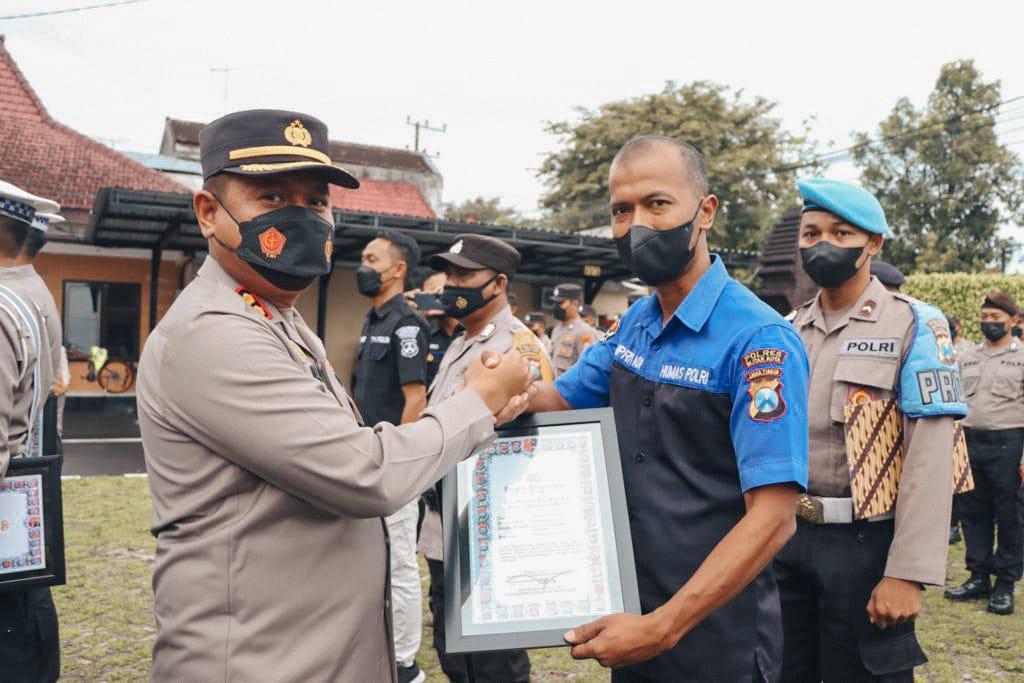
774, 178, 970, 683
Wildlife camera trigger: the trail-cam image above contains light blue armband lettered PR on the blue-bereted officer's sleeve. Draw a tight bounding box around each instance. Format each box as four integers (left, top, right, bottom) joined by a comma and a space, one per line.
899, 302, 967, 418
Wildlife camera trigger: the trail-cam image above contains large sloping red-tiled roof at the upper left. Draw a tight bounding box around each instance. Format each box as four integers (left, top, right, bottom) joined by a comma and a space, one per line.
0, 36, 188, 209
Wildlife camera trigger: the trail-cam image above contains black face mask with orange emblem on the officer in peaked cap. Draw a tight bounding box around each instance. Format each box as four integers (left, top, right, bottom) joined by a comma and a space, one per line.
214, 199, 334, 292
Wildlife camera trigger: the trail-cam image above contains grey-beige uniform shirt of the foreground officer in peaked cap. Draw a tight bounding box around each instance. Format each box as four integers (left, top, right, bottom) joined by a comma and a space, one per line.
137, 258, 494, 682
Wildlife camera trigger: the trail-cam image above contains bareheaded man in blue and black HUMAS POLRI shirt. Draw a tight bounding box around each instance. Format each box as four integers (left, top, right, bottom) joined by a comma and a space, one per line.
530, 136, 808, 682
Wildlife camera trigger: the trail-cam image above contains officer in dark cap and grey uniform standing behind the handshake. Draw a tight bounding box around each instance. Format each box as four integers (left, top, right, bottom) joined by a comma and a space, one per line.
421, 234, 552, 683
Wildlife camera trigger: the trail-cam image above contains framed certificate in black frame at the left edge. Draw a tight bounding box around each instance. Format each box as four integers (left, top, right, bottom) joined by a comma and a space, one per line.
0, 456, 65, 592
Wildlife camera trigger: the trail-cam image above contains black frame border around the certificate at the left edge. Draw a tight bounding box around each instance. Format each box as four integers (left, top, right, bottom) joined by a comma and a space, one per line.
0, 455, 67, 593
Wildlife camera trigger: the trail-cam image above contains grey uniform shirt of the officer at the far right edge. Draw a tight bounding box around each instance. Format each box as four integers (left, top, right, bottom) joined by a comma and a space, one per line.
957, 339, 1024, 430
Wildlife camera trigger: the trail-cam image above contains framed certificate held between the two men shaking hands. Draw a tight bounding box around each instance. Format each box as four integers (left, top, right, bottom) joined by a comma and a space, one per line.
442, 409, 640, 652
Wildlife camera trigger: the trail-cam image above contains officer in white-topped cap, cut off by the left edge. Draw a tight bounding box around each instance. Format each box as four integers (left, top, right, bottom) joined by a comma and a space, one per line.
0, 180, 60, 683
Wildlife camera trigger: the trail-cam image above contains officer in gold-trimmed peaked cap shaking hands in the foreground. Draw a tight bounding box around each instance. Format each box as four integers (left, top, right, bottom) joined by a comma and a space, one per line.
137, 110, 530, 683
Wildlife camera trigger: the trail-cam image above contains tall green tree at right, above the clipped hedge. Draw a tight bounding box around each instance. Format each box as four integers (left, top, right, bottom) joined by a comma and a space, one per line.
852, 59, 1024, 272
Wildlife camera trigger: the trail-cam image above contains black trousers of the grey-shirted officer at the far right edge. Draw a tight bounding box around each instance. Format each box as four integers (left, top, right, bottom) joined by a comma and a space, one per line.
957, 429, 1024, 582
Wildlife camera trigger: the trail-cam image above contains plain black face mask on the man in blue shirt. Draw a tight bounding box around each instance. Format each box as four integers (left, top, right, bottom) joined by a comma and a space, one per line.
614, 197, 703, 286
